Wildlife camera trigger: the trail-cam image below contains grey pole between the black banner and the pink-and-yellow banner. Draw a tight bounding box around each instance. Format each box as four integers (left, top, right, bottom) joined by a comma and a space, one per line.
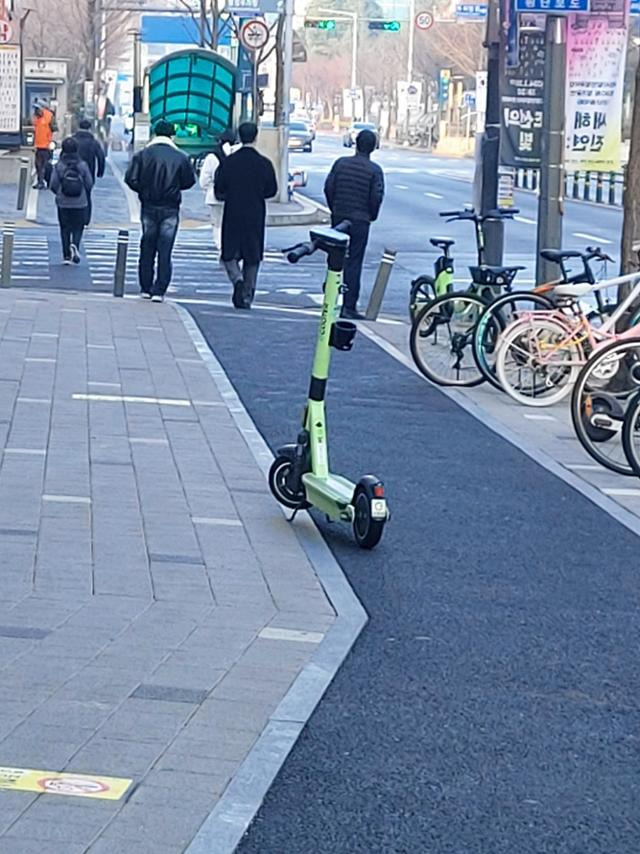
536, 15, 567, 284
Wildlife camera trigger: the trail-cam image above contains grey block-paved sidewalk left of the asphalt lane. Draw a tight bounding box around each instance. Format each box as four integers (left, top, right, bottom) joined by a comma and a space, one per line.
0, 289, 334, 854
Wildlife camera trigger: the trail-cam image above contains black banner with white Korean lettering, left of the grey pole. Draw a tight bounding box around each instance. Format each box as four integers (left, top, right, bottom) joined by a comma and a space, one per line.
500, 30, 545, 169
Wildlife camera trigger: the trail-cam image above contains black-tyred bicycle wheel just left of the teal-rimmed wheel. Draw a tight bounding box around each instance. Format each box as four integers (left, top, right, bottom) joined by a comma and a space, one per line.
410, 293, 487, 386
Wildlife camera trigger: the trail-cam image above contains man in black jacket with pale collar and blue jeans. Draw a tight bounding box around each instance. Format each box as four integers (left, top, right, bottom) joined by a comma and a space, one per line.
125, 120, 196, 302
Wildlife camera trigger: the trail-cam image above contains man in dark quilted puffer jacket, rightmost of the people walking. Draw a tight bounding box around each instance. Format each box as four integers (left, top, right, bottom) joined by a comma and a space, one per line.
324, 130, 384, 320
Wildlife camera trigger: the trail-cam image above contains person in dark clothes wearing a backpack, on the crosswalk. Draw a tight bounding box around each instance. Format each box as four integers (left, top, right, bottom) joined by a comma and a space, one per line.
49, 137, 93, 264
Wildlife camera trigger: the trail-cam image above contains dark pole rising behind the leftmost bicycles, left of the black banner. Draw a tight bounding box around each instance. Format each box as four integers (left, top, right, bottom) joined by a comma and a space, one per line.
480, 0, 504, 264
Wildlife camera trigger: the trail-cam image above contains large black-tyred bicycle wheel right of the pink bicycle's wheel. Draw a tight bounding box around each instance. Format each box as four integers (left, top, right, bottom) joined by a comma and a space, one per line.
571, 338, 640, 475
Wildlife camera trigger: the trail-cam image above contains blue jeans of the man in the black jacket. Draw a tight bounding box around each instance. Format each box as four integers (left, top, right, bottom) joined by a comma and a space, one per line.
138, 206, 178, 296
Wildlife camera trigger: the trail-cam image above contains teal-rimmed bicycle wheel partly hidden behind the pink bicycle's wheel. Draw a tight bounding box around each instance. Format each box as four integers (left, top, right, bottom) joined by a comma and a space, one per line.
472, 291, 553, 390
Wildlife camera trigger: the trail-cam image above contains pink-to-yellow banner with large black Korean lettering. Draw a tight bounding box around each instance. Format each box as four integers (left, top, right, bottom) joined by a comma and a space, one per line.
565, 15, 627, 172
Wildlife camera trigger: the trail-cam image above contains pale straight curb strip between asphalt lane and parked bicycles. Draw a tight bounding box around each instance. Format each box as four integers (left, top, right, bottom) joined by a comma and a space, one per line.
359, 324, 640, 537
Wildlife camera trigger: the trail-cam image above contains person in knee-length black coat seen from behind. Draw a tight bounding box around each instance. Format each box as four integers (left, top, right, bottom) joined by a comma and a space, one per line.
214, 122, 278, 309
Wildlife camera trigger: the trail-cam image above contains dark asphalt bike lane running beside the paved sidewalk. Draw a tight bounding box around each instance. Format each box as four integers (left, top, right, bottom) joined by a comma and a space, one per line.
191, 307, 640, 854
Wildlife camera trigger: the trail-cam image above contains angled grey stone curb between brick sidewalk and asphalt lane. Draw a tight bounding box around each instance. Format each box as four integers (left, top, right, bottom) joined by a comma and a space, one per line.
173, 303, 368, 854
